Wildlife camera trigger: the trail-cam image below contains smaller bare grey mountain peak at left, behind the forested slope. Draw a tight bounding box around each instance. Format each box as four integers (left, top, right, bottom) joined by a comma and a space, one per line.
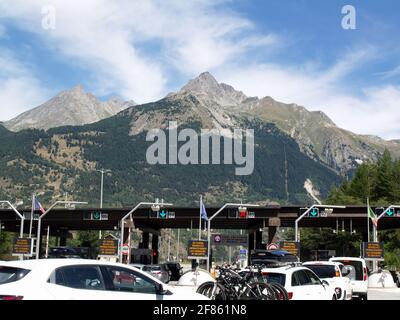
5, 85, 135, 131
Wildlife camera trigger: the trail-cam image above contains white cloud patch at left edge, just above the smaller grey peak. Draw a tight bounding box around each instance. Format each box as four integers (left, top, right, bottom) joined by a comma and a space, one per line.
0, 50, 49, 121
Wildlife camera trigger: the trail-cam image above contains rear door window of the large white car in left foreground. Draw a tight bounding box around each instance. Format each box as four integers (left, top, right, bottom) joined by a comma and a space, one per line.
49, 266, 105, 290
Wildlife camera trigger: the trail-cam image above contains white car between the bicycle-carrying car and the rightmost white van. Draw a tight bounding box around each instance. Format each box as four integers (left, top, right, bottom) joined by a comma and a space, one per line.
303, 261, 353, 300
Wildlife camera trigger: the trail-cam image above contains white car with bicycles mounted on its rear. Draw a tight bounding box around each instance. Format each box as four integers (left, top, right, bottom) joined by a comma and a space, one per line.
262, 266, 337, 300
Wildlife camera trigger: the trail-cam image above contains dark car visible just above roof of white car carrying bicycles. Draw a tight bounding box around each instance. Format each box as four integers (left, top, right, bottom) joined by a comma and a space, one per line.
250, 250, 299, 267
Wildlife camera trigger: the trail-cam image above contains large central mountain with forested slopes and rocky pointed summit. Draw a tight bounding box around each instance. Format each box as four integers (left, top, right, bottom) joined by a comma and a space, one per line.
0, 73, 399, 206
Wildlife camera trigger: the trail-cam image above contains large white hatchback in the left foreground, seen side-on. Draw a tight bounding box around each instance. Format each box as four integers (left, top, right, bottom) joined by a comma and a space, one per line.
0, 259, 207, 300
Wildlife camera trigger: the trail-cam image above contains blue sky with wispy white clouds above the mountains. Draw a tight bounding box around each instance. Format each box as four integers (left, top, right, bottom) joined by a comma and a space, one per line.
0, 0, 400, 139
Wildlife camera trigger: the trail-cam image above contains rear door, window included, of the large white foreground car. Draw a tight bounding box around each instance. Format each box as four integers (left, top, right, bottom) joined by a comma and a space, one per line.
46, 265, 109, 300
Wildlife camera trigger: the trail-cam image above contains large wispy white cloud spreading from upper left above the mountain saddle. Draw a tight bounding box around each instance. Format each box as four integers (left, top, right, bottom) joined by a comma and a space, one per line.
0, 0, 275, 102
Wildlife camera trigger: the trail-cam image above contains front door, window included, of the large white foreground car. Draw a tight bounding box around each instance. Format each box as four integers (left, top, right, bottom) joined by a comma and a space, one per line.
102, 266, 169, 300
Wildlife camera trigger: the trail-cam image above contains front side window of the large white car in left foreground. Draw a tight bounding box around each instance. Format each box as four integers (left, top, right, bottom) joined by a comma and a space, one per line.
106, 266, 157, 294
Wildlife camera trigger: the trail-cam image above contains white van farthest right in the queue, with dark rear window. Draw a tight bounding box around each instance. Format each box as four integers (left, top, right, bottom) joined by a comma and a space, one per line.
329, 257, 368, 300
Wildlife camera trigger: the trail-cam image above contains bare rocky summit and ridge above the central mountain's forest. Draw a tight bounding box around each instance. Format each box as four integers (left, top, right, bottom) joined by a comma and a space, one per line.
127, 72, 400, 175
